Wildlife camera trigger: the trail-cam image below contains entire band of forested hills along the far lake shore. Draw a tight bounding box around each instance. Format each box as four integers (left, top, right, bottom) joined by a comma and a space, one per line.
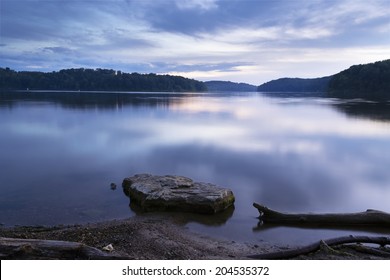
0, 59, 390, 99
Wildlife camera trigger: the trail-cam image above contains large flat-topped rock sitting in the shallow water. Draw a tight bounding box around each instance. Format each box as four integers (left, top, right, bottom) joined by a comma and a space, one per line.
122, 174, 234, 214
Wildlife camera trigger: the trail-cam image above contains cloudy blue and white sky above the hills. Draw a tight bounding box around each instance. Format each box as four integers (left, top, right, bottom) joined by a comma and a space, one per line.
0, 0, 390, 85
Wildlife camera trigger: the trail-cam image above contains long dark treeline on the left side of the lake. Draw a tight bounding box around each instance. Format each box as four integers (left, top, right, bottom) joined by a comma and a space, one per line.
0, 68, 207, 92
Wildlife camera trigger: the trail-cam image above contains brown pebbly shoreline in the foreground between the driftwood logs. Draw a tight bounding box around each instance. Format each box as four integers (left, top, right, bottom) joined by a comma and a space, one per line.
0, 215, 390, 260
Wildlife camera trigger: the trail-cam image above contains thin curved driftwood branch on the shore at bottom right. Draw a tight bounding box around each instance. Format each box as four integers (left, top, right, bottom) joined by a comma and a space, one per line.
248, 235, 390, 260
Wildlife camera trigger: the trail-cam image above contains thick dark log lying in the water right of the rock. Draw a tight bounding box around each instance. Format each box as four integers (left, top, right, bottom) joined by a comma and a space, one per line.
253, 203, 390, 228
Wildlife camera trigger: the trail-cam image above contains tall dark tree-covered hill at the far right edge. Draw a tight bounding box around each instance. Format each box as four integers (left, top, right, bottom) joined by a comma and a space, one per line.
328, 59, 390, 99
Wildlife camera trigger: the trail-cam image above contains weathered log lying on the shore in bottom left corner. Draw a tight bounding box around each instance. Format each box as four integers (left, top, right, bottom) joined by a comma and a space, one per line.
0, 237, 129, 259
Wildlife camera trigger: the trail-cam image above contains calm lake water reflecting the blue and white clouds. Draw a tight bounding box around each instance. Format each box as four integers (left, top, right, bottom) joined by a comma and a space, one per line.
0, 92, 390, 243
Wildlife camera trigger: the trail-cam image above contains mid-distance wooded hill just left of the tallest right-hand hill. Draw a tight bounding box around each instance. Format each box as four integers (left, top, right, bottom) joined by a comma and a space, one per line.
257, 76, 331, 93
